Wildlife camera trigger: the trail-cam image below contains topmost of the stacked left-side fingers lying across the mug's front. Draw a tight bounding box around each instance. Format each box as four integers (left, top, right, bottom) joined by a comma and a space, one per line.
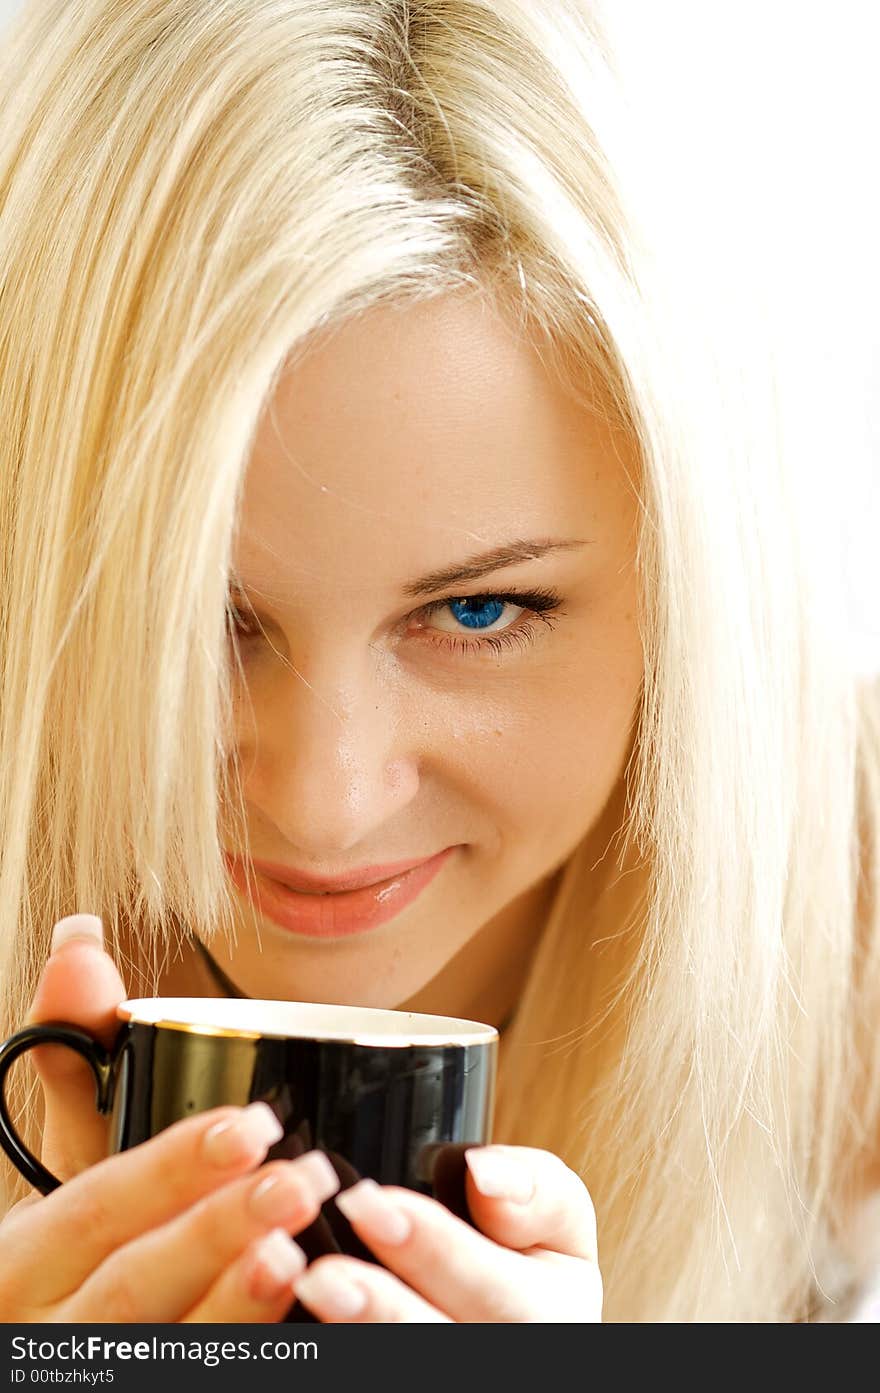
4, 1103, 288, 1300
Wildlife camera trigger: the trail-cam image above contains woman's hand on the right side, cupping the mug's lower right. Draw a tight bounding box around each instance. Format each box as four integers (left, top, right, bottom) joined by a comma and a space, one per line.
295, 1146, 602, 1323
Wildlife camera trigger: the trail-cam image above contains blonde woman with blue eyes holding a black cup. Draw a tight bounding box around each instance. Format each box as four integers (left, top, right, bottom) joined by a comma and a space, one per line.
0, 0, 880, 1321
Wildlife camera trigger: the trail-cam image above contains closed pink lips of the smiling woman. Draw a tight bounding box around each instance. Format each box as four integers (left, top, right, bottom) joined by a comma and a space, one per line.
226, 847, 457, 939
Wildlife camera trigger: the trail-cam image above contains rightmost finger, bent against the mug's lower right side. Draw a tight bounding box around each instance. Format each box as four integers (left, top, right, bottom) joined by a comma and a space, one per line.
465, 1145, 599, 1263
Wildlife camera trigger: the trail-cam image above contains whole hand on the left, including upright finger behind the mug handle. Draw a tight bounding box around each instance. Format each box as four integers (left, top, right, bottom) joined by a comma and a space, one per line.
0, 915, 338, 1323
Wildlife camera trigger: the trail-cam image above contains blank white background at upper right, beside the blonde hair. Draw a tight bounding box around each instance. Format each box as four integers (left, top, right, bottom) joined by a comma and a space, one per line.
0, 0, 880, 671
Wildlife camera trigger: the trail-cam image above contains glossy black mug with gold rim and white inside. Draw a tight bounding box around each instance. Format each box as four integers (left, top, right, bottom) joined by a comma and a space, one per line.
0, 996, 498, 1323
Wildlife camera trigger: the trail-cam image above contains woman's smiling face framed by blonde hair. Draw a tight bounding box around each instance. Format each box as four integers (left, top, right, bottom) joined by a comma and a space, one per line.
214, 293, 642, 1006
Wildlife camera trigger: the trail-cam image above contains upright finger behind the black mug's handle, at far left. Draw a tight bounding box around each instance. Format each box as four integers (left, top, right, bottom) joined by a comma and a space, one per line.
26, 914, 127, 1180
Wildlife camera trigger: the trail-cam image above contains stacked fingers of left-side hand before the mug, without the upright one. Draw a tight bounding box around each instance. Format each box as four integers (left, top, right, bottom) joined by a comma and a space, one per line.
0, 1103, 338, 1323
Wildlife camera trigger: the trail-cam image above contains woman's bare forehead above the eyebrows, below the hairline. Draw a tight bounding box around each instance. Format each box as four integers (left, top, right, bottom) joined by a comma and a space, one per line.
235, 293, 625, 600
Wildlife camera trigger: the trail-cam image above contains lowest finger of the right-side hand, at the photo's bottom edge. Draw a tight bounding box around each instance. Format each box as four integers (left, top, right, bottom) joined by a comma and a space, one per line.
294, 1254, 450, 1325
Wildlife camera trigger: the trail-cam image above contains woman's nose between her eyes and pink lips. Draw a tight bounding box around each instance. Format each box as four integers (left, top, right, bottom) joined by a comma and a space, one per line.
237, 652, 421, 869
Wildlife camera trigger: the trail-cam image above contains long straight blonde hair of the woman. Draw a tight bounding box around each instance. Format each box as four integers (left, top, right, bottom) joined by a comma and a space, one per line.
0, 0, 880, 1321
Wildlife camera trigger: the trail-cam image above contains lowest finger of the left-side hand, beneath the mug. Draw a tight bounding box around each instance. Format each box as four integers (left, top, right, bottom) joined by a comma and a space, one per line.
184, 1229, 305, 1325
